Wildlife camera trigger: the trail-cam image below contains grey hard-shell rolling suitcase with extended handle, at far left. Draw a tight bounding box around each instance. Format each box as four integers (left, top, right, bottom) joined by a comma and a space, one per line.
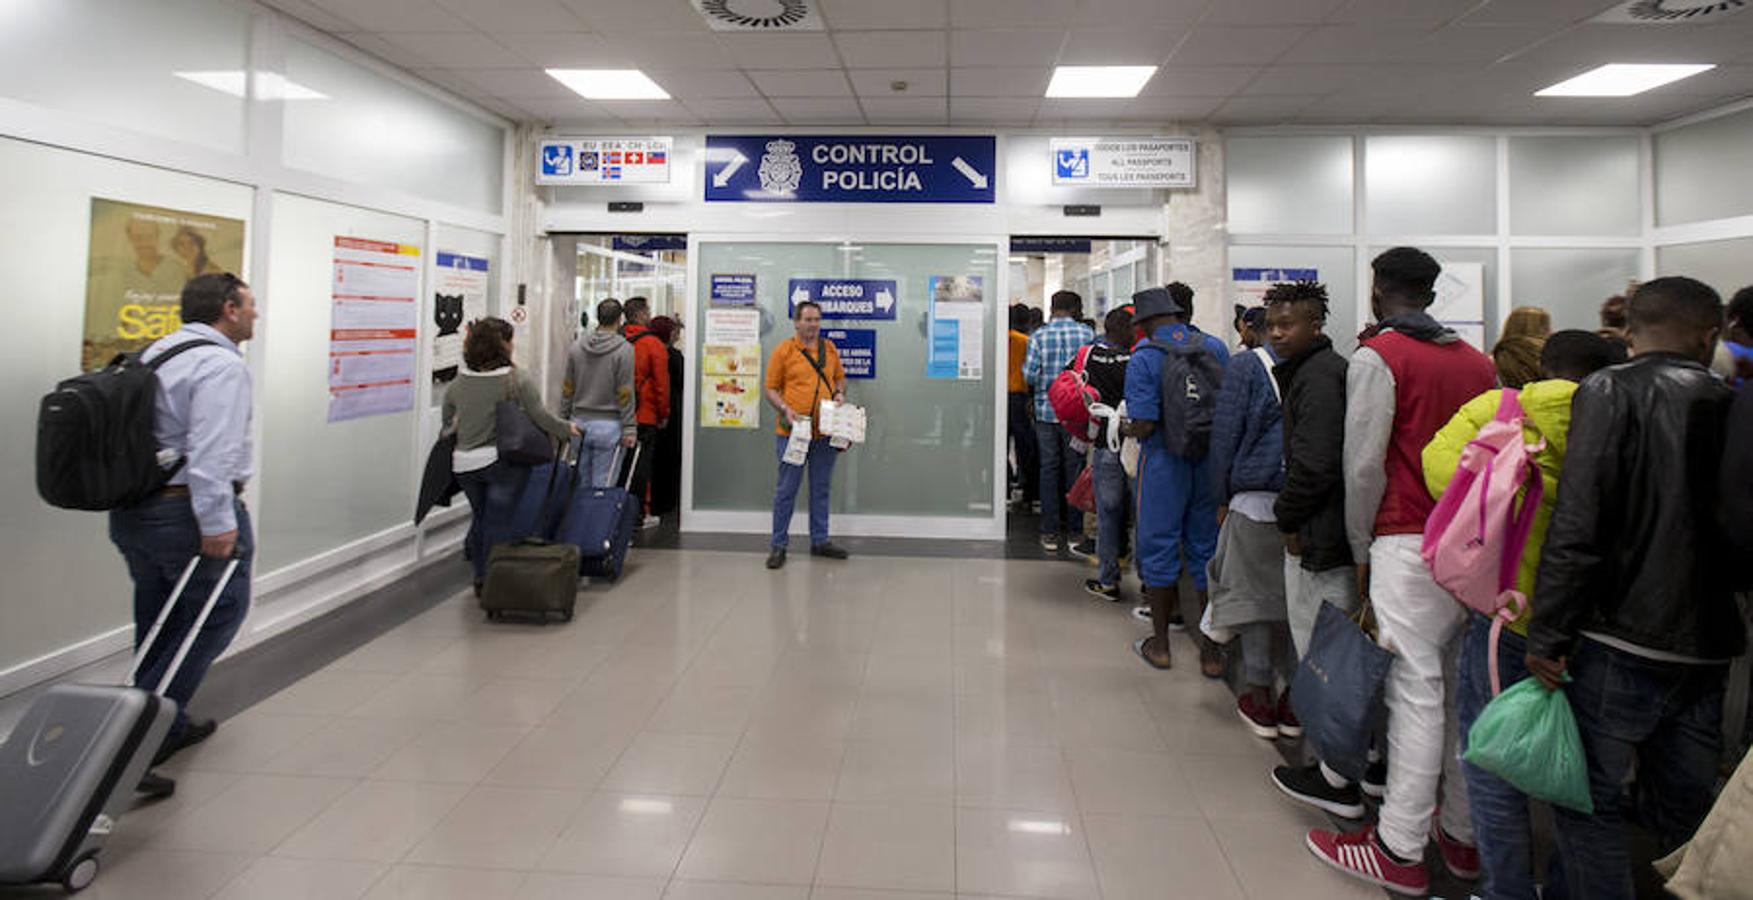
0, 556, 237, 891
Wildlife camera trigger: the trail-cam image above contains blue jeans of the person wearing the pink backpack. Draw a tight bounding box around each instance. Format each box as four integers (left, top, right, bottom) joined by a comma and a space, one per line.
1455, 612, 1557, 900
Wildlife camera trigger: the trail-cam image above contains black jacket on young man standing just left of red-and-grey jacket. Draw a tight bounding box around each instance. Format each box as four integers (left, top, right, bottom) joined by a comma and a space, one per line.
1273, 337, 1352, 572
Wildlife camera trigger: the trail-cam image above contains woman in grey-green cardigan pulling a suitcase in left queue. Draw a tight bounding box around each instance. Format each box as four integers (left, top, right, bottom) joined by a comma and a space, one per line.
444, 318, 578, 596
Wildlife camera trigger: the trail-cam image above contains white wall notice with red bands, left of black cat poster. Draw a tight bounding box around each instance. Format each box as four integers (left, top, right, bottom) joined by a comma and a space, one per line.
328, 237, 421, 423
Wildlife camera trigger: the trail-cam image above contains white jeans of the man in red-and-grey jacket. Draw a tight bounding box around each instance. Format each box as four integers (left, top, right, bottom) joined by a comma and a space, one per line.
1369, 535, 1473, 860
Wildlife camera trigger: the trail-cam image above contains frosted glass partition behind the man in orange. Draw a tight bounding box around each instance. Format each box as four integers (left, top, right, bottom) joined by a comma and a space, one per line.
684, 240, 1006, 539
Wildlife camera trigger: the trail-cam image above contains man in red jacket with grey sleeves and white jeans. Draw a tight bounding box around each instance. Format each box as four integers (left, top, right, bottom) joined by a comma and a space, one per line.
1308, 247, 1497, 893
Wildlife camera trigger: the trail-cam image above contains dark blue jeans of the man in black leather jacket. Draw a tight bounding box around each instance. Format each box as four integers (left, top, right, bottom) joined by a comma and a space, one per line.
1553, 637, 1728, 900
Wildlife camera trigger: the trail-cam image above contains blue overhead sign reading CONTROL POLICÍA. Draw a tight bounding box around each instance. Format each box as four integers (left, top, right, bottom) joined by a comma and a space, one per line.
706, 135, 997, 204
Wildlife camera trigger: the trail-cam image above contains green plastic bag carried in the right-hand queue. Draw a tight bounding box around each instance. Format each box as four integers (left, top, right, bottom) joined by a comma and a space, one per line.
1462, 677, 1595, 814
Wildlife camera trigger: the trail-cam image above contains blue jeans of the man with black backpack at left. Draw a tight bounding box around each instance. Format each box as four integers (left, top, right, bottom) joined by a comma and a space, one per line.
110, 495, 256, 740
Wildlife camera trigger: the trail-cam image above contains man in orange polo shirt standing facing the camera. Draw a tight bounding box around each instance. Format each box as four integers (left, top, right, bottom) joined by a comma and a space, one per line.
766, 300, 847, 568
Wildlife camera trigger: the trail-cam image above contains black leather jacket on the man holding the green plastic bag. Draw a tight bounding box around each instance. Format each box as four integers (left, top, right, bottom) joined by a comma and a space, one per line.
1529, 353, 1746, 660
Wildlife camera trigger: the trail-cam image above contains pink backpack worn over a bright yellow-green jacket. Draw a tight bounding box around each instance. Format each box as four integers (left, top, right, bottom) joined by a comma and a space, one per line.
1422, 388, 1546, 695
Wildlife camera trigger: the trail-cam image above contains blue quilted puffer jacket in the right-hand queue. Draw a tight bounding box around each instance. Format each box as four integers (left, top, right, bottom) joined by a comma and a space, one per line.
1211, 351, 1285, 505
